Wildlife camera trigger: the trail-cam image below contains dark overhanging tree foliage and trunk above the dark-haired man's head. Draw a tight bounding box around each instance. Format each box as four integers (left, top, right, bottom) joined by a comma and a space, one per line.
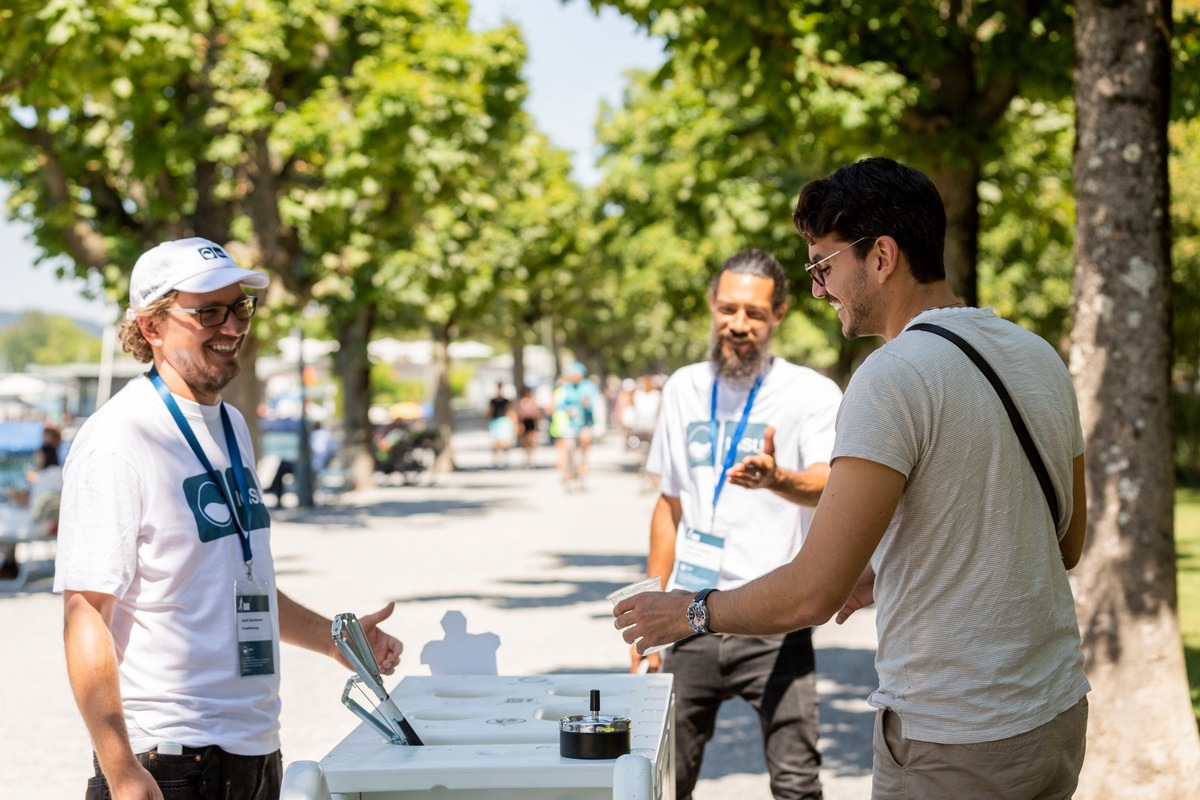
592, 0, 1070, 302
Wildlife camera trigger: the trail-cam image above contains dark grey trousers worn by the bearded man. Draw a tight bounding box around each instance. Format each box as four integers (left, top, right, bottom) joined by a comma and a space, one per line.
662, 628, 822, 800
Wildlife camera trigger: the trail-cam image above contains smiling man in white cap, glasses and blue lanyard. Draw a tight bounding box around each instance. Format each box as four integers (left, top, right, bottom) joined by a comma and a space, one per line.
54, 239, 402, 800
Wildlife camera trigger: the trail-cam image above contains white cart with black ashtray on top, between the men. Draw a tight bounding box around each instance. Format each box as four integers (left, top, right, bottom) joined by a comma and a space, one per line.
281, 673, 674, 800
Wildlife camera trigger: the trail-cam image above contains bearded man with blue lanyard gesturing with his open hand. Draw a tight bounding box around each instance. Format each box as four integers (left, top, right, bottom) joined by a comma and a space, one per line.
632, 249, 841, 800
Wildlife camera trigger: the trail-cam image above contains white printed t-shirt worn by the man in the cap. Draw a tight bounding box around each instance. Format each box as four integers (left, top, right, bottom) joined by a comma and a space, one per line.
54, 378, 280, 756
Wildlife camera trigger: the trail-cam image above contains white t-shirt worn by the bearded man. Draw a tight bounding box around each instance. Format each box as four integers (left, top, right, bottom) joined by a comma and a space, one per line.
646, 357, 841, 589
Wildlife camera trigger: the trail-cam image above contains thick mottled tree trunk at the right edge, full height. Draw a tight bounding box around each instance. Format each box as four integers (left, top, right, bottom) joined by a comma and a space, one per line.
1070, 0, 1200, 800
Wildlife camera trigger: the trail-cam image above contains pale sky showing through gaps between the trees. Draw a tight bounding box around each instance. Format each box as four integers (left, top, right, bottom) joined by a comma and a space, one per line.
0, 0, 664, 323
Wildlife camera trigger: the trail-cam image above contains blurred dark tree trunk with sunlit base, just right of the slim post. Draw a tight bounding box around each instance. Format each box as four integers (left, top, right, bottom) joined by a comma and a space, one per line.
334, 306, 376, 489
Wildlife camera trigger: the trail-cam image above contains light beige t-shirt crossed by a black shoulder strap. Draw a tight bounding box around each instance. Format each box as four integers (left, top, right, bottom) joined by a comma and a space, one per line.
834, 308, 1088, 744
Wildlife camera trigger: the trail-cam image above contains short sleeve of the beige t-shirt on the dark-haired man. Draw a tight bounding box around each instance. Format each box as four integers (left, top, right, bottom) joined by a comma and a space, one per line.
833, 351, 932, 477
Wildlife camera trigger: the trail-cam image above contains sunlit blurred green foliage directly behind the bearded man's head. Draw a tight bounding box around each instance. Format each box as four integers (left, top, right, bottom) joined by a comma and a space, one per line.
590, 65, 836, 376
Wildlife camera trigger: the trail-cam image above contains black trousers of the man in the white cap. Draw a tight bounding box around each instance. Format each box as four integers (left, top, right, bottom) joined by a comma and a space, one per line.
84, 746, 283, 800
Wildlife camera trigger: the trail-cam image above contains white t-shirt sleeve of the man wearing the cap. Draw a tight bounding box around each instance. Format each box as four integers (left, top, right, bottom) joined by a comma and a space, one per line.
54, 450, 142, 597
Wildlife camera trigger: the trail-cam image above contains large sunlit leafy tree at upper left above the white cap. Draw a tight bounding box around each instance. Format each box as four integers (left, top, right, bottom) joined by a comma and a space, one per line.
0, 0, 576, 482
